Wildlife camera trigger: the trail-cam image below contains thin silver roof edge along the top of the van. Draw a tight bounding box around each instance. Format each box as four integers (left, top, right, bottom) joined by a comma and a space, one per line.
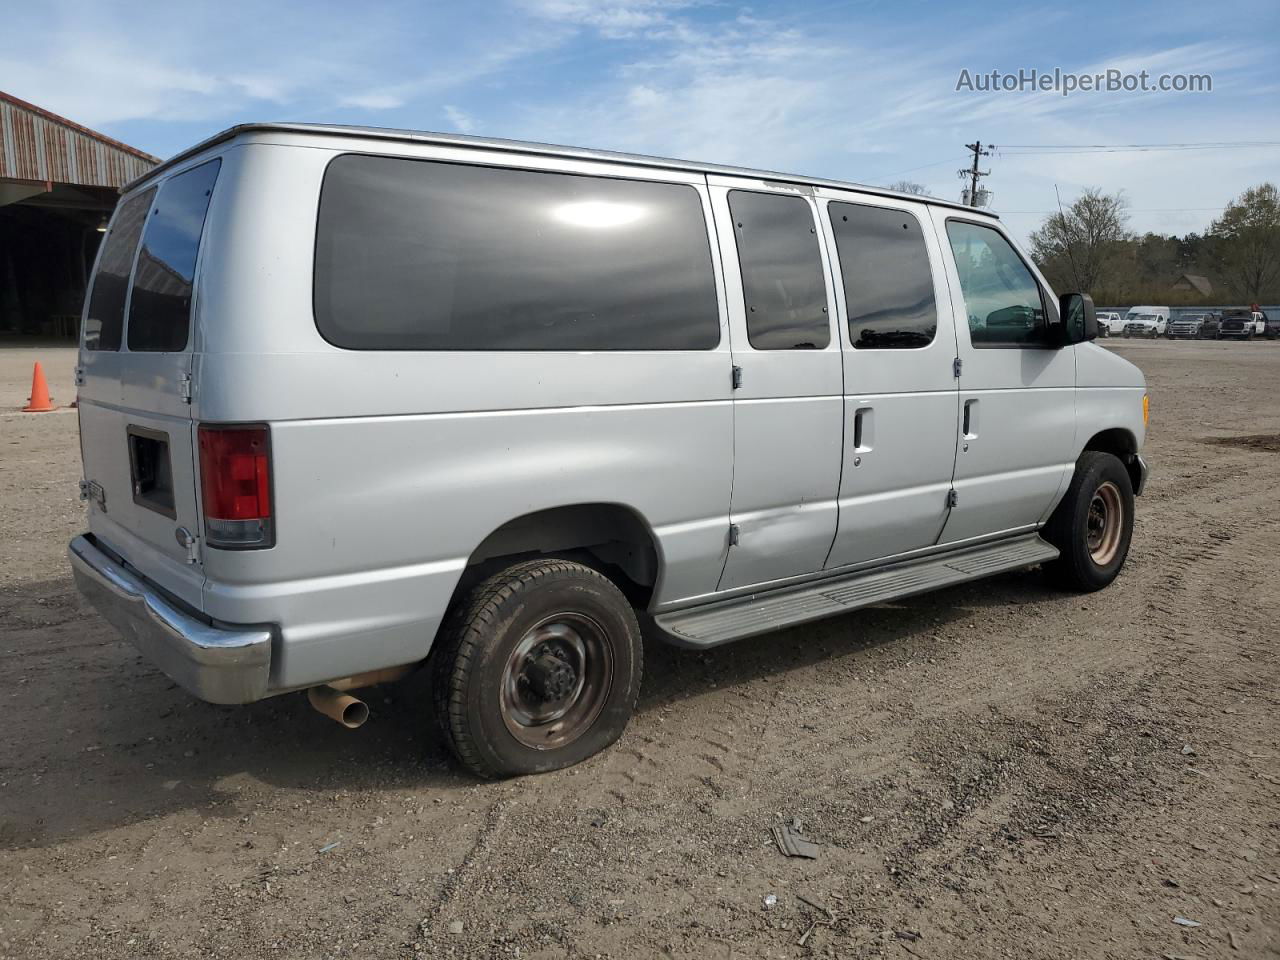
120, 123, 1000, 219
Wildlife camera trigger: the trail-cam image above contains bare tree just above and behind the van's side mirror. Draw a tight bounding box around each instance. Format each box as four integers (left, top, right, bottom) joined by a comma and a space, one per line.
1030, 187, 1133, 293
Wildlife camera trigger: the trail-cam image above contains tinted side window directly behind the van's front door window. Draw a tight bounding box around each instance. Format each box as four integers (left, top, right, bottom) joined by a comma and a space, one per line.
827, 204, 938, 349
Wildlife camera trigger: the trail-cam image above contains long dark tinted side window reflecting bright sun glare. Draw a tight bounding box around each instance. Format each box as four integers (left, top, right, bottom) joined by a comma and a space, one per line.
315, 155, 719, 351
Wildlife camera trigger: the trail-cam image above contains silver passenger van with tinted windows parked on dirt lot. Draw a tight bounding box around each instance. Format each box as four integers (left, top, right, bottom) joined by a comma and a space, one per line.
69, 124, 1147, 777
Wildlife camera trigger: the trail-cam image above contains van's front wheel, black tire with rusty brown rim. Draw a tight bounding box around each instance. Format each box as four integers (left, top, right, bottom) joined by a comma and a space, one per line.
1043, 451, 1133, 593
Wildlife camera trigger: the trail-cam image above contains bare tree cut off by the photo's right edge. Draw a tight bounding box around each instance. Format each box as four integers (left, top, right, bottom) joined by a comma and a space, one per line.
1208, 183, 1280, 303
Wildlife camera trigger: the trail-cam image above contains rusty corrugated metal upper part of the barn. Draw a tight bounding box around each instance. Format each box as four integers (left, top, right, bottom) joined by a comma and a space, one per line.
0, 91, 160, 188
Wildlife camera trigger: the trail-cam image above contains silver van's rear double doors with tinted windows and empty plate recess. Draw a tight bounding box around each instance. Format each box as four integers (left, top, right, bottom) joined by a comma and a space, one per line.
78, 159, 220, 608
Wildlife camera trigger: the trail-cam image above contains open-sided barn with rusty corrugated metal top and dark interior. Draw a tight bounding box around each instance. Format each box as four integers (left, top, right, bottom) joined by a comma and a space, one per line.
0, 91, 160, 338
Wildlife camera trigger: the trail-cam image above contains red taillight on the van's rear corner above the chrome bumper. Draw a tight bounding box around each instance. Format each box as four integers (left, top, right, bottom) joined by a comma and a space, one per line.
200, 425, 275, 549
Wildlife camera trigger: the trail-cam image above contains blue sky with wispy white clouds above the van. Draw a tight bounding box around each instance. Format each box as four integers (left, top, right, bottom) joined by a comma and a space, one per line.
0, 0, 1280, 236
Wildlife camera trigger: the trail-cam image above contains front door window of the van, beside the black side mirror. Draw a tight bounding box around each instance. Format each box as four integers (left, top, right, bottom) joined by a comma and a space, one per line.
947, 220, 1050, 347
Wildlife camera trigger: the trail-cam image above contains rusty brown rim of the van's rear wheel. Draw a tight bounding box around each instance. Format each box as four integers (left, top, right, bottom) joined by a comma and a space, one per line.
502, 613, 613, 750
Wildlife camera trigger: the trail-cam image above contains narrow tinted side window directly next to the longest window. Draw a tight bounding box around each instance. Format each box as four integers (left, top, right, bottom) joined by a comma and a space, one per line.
728, 189, 831, 349
